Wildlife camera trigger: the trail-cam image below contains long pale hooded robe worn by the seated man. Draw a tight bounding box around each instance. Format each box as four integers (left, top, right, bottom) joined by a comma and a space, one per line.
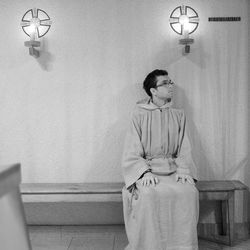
122, 99, 199, 250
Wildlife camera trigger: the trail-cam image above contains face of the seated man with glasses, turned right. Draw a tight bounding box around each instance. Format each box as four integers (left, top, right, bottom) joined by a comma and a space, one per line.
152, 75, 174, 100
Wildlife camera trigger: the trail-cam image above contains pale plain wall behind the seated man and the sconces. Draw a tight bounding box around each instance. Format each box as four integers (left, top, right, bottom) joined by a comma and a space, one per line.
0, 0, 250, 188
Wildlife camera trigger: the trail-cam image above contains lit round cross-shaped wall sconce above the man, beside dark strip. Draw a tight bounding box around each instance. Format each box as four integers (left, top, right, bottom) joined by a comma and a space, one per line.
169, 5, 199, 53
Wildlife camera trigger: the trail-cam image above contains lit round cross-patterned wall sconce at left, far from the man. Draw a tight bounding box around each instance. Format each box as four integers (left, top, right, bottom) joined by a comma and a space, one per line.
21, 8, 52, 57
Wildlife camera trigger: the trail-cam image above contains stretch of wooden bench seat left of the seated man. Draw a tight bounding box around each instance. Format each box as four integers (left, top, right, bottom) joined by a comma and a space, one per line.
21, 182, 124, 203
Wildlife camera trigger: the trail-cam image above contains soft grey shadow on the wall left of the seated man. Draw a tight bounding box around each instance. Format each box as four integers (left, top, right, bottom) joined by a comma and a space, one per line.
86, 83, 145, 182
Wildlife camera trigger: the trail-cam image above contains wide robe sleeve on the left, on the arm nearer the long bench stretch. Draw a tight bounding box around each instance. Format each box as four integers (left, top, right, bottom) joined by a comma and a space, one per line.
122, 112, 150, 188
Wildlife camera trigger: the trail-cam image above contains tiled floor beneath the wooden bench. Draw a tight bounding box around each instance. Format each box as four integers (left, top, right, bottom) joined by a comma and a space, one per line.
29, 225, 250, 250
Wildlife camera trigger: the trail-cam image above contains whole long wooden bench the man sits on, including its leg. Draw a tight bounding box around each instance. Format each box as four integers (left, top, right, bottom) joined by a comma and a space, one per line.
21, 180, 247, 245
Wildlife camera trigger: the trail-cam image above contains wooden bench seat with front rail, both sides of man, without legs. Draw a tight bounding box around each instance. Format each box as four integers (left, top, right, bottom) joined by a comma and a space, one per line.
20, 180, 247, 202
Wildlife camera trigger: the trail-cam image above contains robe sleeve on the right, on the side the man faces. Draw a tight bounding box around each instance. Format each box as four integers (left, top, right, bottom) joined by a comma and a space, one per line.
175, 111, 197, 180
